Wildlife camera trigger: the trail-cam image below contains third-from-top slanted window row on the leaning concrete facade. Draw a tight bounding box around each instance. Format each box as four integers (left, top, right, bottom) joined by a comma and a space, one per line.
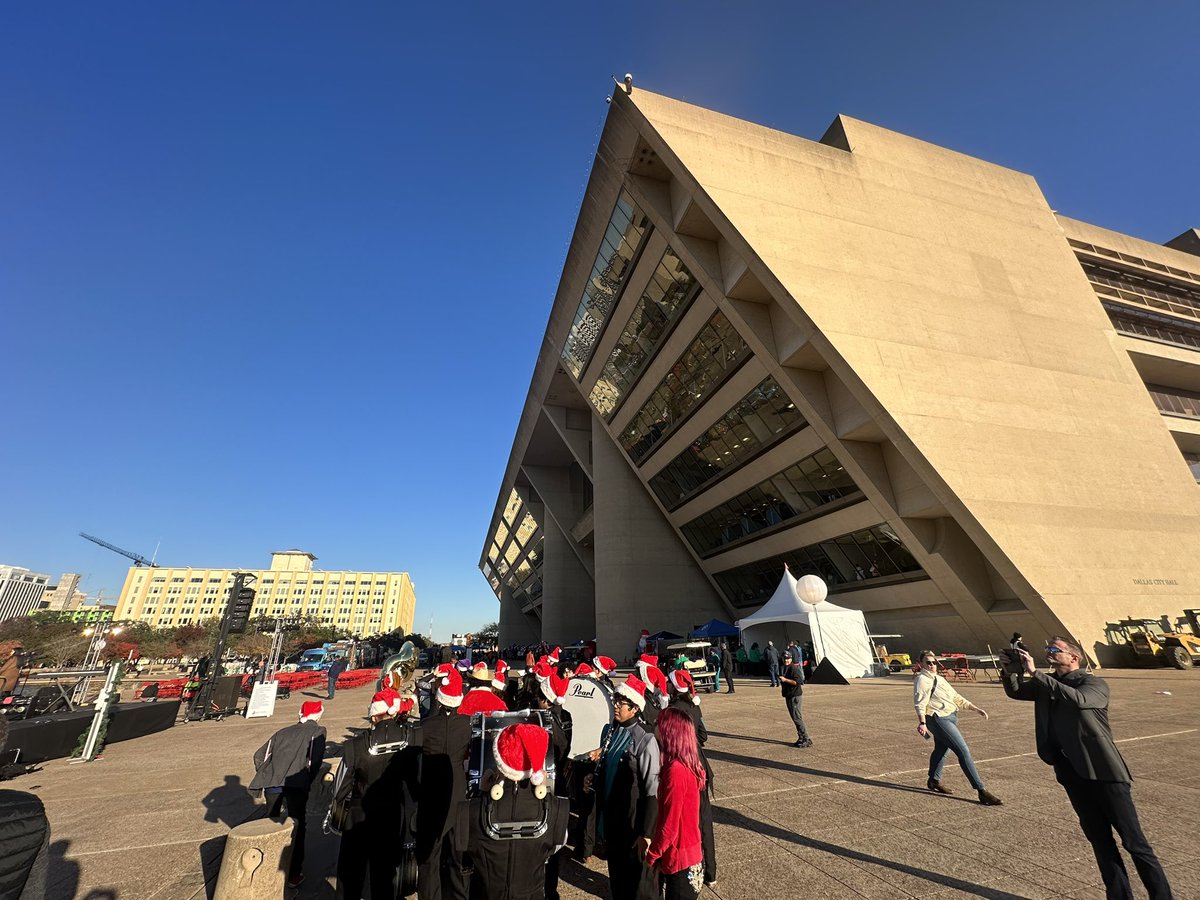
620, 312, 750, 463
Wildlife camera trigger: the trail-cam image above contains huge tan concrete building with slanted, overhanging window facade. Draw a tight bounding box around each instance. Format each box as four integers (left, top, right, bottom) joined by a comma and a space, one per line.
480, 89, 1200, 659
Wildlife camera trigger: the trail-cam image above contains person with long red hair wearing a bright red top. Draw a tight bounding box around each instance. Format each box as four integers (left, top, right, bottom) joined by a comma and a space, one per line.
646, 707, 704, 900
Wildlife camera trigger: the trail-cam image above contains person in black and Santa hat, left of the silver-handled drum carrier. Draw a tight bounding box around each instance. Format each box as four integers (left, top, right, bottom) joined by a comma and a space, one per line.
416, 662, 470, 900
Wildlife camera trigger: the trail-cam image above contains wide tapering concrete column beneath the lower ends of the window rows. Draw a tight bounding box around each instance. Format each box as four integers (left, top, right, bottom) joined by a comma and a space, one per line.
592, 419, 728, 661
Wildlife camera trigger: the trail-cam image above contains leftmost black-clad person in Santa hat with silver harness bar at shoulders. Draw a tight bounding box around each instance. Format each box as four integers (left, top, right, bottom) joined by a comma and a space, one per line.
334, 688, 421, 900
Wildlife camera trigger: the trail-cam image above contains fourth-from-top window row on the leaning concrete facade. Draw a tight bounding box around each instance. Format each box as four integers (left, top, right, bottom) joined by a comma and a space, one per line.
650, 377, 808, 509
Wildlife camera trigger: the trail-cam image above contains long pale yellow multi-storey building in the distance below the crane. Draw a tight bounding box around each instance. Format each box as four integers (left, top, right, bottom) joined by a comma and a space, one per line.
116, 550, 416, 637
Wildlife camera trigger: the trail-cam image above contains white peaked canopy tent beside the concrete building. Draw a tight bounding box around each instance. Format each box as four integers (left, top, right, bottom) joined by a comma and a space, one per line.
737, 569, 874, 678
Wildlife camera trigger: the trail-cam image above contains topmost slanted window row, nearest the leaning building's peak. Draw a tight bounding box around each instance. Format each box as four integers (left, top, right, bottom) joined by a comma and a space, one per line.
563, 191, 650, 379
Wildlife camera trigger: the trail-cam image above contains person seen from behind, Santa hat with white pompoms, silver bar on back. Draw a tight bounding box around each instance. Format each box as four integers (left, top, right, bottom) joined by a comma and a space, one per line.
462, 725, 570, 900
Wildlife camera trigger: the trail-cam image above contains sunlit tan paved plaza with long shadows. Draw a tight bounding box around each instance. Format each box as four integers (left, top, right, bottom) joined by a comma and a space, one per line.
23, 670, 1200, 900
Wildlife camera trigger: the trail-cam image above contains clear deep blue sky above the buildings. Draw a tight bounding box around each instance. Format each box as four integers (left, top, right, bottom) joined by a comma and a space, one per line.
0, 0, 1200, 636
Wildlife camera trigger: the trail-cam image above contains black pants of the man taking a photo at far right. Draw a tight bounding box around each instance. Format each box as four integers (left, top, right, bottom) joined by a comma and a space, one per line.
1054, 762, 1172, 900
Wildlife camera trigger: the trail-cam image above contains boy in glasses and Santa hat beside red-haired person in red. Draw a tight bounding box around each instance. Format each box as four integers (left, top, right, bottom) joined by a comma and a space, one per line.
589, 674, 659, 900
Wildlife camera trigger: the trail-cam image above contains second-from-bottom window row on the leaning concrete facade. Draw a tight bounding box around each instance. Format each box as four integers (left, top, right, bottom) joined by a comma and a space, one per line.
682, 448, 862, 556
